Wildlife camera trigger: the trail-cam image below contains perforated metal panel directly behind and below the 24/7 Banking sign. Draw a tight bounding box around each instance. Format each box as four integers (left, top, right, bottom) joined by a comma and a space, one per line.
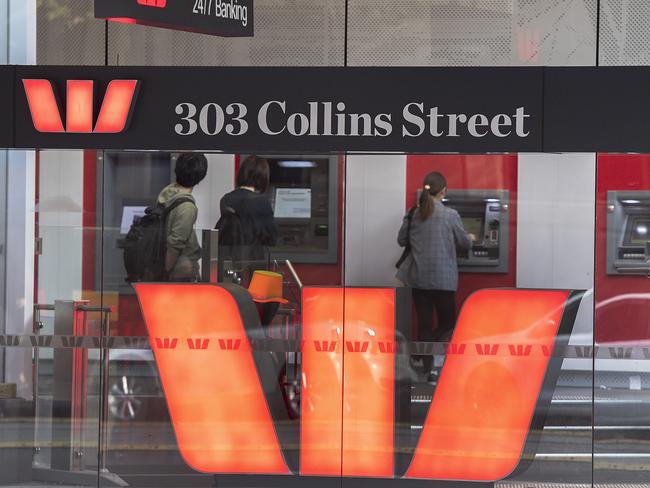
109, 0, 345, 66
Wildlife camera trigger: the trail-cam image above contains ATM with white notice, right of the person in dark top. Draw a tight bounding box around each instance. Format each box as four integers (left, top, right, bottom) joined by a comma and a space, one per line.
253, 155, 339, 264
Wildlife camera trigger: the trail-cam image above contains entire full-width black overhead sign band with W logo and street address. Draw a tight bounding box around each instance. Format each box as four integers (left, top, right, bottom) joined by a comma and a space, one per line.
0, 66, 650, 153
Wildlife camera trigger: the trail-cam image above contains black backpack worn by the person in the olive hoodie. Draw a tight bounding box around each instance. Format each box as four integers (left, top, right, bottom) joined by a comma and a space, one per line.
123, 197, 194, 283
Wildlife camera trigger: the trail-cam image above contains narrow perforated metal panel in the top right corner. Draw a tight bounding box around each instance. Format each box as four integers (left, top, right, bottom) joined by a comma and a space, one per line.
599, 0, 650, 66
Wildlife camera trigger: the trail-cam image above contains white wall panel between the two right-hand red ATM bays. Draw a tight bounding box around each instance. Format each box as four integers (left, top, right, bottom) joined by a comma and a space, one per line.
517, 154, 596, 344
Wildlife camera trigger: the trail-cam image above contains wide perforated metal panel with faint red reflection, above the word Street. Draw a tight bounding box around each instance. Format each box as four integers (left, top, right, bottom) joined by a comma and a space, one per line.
348, 0, 596, 66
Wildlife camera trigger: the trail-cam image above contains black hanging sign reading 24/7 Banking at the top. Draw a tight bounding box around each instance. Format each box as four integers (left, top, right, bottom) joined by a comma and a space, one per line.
95, 0, 254, 37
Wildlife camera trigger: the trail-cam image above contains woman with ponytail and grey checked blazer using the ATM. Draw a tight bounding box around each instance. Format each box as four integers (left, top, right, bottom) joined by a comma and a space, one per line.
397, 172, 476, 378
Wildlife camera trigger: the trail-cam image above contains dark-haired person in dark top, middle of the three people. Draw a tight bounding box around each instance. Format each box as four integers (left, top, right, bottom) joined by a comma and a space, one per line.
217, 155, 278, 286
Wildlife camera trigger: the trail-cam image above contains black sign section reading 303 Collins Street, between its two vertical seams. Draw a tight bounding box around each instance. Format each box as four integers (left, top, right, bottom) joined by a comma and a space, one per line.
15, 66, 543, 153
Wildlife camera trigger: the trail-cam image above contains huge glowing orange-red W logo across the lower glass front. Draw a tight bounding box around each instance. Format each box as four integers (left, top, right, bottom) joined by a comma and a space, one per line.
135, 284, 582, 481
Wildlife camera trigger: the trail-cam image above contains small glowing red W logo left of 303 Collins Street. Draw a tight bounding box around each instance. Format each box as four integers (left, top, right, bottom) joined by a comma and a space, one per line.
23, 79, 140, 134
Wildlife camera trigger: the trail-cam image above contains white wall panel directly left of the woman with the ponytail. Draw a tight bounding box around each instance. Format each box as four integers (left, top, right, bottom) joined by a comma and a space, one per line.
345, 154, 406, 286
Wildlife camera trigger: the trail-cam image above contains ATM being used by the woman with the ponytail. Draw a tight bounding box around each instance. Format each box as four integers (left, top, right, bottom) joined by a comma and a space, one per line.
418, 190, 510, 273
